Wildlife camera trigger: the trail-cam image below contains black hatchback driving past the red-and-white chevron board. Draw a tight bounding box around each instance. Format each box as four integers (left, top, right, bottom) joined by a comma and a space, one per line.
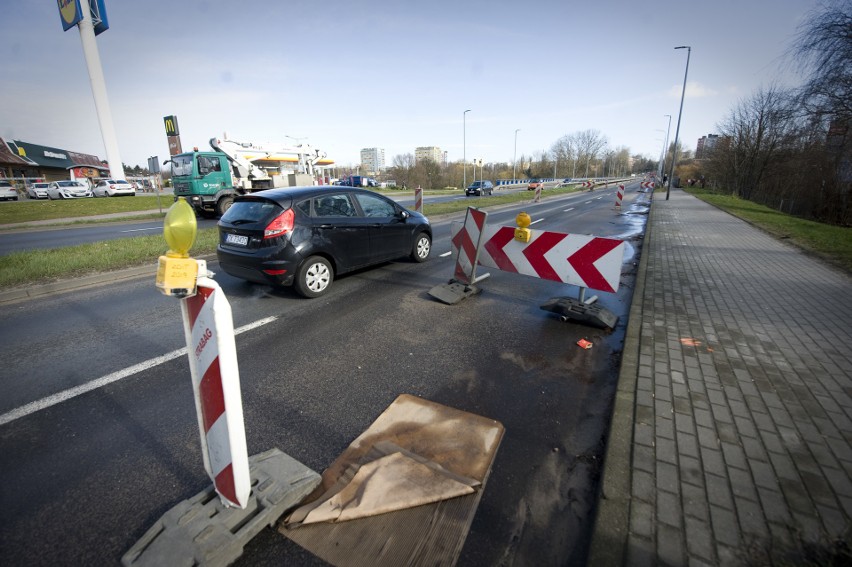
216, 185, 432, 297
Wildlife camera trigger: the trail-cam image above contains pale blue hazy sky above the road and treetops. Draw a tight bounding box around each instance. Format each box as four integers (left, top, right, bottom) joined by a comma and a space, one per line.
0, 0, 815, 171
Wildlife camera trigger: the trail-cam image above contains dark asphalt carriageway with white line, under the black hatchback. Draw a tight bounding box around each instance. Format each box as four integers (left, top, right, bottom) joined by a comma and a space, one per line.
0, 185, 647, 565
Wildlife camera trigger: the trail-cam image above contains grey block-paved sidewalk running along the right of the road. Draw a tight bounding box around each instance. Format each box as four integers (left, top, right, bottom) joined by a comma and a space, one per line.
589, 190, 852, 565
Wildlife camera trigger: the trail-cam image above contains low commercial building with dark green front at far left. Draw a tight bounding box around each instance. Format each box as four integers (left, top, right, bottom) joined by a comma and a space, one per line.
0, 138, 109, 183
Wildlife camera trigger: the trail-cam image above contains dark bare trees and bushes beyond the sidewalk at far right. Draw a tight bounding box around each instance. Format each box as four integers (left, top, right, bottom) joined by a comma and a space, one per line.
676, 0, 852, 225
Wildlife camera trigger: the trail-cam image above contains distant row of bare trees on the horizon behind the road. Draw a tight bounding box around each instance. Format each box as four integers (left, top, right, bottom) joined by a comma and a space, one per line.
387, 130, 657, 188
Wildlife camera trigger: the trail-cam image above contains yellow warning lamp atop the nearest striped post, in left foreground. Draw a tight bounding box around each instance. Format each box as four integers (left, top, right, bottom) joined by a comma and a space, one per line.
157, 197, 198, 297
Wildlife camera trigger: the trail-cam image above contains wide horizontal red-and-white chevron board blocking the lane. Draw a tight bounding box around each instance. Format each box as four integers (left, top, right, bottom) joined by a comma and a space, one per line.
453, 224, 625, 293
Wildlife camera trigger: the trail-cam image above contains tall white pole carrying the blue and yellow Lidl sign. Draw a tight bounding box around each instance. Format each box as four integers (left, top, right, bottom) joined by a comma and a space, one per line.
57, 0, 124, 179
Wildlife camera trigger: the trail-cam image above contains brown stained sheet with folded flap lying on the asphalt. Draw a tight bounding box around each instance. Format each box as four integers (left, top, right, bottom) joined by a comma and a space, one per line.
279, 395, 503, 565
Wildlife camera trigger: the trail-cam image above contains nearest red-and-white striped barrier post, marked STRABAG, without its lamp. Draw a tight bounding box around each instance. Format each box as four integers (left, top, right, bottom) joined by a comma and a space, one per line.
180, 278, 251, 508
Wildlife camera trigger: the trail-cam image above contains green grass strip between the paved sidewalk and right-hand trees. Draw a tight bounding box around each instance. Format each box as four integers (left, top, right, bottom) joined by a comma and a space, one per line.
685, 187, 852, 274
